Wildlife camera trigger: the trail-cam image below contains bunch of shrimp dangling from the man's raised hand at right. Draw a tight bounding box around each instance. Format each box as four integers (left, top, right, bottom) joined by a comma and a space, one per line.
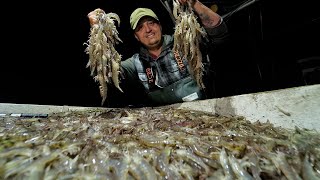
173, 0, 207, 88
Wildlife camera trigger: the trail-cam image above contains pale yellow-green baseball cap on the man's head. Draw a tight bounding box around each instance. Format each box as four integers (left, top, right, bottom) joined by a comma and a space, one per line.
130, 8, 159, 30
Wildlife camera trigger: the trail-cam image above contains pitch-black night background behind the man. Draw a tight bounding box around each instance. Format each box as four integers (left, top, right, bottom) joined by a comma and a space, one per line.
0, 0, 320, 107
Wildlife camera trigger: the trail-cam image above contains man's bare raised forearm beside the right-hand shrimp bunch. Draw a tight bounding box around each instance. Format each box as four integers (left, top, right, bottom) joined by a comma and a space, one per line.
193, 0, 221, 28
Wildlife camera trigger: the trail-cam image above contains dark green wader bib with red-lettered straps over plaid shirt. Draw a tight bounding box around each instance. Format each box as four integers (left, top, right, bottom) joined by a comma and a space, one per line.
132, 50, 203, 104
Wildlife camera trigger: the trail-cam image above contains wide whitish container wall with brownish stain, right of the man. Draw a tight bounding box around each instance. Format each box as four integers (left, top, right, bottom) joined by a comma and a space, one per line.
175, 84, 320, 131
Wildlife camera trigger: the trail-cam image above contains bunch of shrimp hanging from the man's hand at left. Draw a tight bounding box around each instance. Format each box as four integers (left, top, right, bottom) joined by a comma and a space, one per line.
85, 9, 123, 106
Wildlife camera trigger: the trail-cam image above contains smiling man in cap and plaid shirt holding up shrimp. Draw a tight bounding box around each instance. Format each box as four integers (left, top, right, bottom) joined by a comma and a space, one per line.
88, 0, 227, 106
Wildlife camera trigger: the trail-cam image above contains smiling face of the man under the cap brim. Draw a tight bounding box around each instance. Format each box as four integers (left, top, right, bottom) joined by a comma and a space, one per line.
134, 16, 162, 49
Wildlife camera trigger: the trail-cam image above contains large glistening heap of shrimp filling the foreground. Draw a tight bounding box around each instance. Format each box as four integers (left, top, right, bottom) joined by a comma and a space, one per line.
0, 107, 320, 180
